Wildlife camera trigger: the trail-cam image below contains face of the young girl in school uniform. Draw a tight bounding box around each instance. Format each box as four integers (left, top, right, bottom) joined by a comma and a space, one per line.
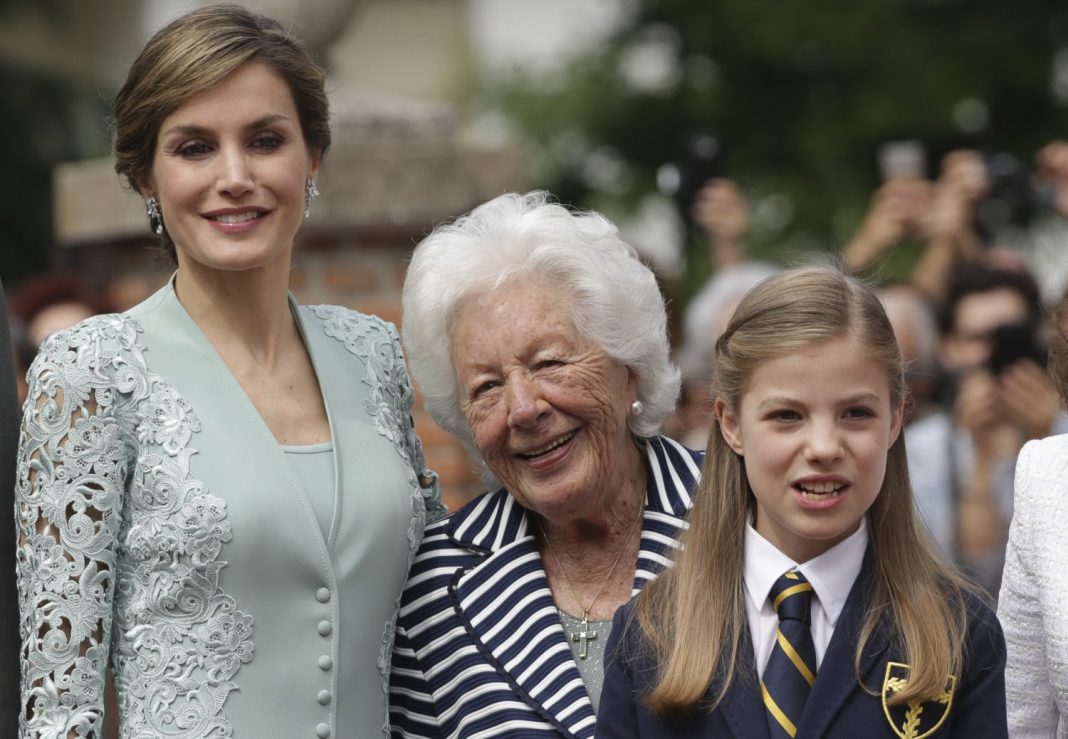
716, 337, 902, 563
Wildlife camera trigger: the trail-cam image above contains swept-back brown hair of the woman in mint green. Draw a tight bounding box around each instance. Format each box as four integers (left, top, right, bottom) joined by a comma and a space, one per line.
113, 4, 330, 258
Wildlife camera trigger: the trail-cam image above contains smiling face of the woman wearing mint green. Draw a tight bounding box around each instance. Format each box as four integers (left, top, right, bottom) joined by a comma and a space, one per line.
140, 62, 318, 271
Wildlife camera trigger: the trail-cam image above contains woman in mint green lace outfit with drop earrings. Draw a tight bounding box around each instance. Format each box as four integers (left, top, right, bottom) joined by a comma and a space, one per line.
16, 5, 440, 739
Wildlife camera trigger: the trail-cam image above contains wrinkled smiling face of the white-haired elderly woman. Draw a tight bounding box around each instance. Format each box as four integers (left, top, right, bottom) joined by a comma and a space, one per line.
452, 283, 645, 524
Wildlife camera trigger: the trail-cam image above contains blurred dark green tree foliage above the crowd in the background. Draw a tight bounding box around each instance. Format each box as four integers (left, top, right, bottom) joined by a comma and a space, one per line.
474, 0, 1068, 301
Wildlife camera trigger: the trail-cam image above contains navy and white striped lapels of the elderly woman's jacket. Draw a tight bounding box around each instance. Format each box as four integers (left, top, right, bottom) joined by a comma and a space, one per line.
449, 437, 701, 738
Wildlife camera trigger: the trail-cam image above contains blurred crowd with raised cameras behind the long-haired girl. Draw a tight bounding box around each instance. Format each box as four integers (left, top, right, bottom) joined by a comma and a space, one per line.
670, 141, 1068, 595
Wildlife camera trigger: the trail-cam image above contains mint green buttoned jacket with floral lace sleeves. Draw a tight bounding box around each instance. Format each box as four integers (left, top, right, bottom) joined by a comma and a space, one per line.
10, 284, 443, 739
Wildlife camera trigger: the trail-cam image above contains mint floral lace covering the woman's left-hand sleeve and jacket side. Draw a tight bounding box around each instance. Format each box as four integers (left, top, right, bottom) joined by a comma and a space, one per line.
16, 316, 253, 739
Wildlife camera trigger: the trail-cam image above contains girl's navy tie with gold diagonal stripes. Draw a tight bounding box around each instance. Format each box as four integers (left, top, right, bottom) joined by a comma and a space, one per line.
760, 569, 816, 739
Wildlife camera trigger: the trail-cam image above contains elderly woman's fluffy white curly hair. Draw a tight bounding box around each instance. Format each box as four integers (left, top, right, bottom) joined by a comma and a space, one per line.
403, 191, 679, 451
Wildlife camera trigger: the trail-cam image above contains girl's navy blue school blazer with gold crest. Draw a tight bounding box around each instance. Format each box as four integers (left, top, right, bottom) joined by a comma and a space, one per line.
597, 549, 1008, 739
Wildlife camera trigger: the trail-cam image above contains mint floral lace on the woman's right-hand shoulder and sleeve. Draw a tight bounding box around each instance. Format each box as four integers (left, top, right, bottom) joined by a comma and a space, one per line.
311, 305, 445, 733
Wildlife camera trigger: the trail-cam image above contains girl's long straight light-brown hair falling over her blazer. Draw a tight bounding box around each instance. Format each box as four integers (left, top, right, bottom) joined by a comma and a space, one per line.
637, 268, 972, 713
